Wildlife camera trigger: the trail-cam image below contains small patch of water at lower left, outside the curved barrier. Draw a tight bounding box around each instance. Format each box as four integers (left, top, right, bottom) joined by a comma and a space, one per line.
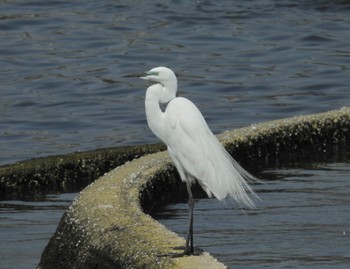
0, 193, 77, 269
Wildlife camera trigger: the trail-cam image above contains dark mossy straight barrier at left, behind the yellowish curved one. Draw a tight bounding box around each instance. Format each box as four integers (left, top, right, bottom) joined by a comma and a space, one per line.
0, 144, 165, 200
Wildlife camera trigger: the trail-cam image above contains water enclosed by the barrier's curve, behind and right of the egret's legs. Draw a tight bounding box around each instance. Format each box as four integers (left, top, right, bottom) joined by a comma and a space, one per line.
158, 163, 350, 269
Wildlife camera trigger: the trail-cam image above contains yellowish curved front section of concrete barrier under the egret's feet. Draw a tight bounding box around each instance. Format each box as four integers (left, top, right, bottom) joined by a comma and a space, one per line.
39, 152, 224, 268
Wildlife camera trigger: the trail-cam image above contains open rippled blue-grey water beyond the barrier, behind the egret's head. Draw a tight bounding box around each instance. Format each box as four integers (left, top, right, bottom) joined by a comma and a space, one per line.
0, 0, 350, 165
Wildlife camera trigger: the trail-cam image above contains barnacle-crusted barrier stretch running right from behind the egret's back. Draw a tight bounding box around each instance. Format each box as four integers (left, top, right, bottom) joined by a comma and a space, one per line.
219, 108, 350, 168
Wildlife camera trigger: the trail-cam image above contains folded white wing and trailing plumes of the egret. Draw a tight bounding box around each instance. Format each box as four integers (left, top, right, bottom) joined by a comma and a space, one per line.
164, 98, 254, 206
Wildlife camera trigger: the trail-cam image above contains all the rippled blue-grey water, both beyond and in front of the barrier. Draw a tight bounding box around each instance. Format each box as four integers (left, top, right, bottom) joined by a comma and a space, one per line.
0, 0, 350, 268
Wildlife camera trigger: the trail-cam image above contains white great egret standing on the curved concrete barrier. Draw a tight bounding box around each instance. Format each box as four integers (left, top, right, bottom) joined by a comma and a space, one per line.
141, 67, 255, 255
